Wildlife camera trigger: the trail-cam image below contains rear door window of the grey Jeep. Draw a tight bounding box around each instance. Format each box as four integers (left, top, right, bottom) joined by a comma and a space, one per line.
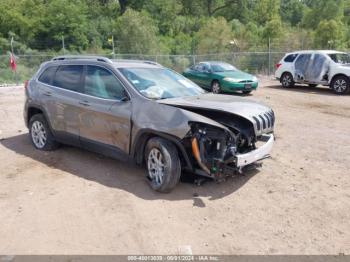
53, 65, 83, 92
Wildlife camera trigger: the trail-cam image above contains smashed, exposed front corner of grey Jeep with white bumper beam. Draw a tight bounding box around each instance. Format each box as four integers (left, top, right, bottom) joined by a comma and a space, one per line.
185, 118, 274, 181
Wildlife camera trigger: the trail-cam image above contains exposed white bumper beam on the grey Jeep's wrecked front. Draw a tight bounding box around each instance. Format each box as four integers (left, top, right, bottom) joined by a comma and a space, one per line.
236, 134, 275, 167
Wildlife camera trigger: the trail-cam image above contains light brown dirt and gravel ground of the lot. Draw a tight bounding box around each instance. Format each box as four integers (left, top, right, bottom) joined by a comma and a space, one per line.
0, 78, 350, 254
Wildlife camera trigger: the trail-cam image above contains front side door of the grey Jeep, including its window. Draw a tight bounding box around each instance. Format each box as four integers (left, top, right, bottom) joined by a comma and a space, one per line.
80, 65, 131, 154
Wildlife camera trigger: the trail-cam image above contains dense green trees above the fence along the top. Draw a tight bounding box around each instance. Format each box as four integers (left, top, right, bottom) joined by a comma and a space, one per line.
0, 0, 350, 55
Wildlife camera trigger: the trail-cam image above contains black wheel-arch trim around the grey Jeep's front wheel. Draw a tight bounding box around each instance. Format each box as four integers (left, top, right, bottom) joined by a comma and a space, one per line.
130, 128, 194, 171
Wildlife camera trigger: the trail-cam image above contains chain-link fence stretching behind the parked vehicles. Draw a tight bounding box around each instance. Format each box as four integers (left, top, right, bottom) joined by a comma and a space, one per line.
0, 52, 284, 85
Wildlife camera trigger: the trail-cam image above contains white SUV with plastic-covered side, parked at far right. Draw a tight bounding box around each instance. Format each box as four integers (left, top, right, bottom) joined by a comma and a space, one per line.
275, 50, 350, 94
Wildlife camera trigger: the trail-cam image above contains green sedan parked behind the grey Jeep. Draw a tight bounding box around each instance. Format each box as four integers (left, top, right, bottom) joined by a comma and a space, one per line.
182, 62, 258, 94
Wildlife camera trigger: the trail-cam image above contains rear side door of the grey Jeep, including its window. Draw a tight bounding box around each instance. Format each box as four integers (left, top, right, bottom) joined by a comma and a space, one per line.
38, 65, 83, 145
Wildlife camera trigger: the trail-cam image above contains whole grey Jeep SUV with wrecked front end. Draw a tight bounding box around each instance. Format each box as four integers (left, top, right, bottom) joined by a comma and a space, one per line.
24, 56, 275, 192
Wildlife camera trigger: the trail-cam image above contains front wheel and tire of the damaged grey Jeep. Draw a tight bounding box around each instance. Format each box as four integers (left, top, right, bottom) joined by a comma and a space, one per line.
145, 137, 181, 193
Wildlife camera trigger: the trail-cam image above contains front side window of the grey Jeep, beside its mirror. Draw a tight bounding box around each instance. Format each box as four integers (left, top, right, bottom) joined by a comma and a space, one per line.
84, 65, 125, 100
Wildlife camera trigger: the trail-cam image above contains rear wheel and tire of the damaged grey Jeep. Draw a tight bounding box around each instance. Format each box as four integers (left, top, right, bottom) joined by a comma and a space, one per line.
29, 114, 59, 151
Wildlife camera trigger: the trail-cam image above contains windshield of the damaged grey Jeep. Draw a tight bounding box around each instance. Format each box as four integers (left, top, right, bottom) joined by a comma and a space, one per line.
119, 68, 205, 99
